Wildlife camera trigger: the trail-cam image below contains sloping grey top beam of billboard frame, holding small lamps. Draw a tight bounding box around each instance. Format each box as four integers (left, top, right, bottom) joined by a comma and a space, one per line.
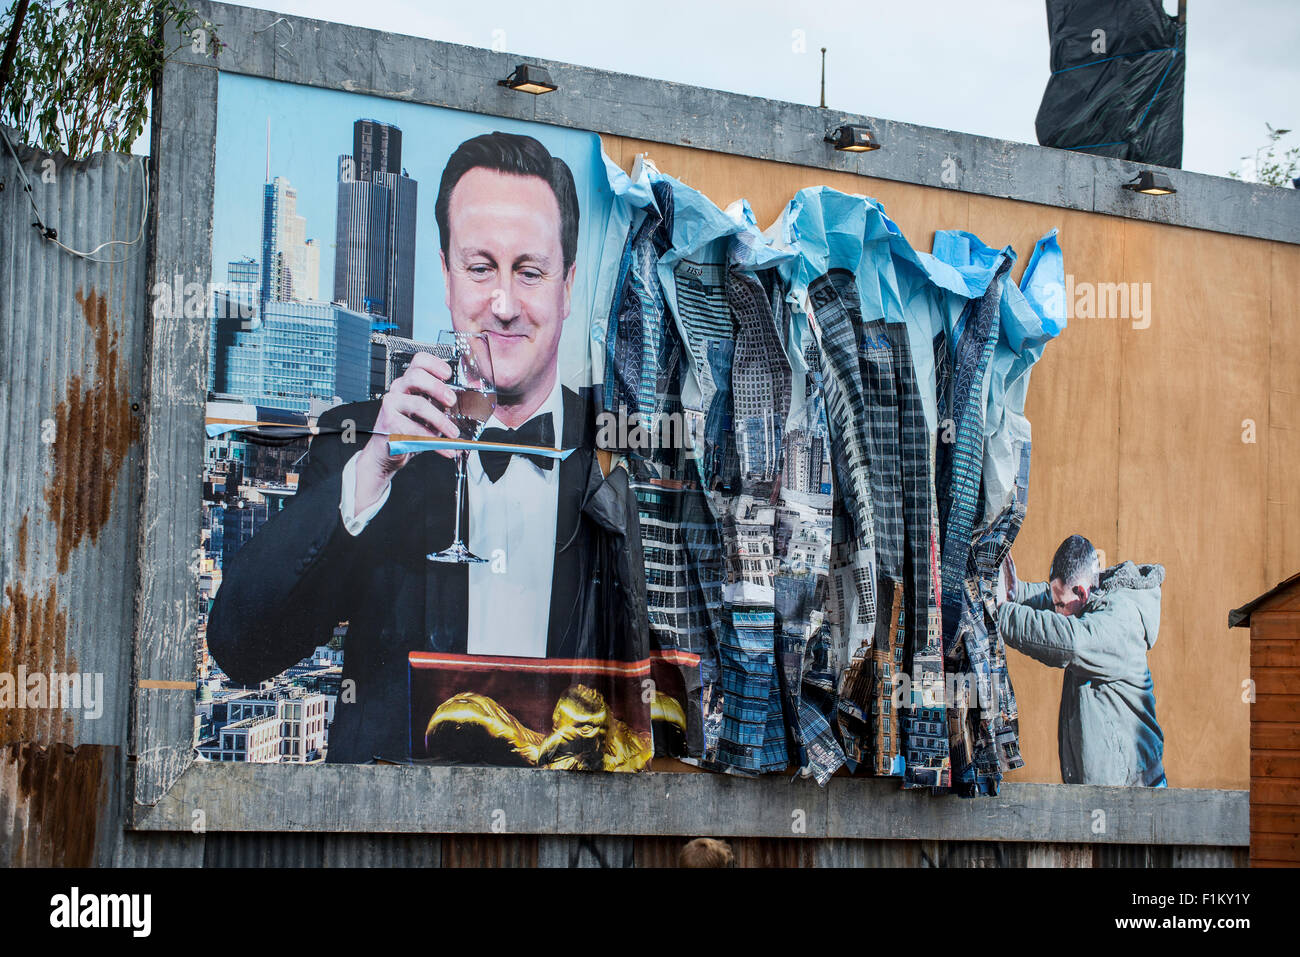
189, 0, 1300, 243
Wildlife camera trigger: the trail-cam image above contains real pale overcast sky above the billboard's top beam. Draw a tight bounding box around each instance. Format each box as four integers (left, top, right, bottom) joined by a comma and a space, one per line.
218, 0, 1300, 176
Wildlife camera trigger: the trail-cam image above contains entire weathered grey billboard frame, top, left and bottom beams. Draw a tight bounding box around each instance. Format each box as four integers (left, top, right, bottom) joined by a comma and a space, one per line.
129, 3, 1258, 846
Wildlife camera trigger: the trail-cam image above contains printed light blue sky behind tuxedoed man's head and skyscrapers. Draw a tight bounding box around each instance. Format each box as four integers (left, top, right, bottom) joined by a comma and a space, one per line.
211, 73, 610, 361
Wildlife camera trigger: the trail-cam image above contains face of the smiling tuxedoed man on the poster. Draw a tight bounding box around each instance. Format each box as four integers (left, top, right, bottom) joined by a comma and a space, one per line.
442, 166, 576, 404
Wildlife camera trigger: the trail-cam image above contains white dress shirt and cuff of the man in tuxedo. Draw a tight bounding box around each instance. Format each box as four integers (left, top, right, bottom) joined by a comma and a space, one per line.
339, 381, 564, 658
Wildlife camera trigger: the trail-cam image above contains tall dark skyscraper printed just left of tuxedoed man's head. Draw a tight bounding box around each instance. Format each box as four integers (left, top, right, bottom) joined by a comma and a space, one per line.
334, 120, 419, 394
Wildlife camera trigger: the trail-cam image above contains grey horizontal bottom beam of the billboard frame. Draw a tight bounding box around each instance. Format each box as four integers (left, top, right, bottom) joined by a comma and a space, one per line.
134, 763, 1249, 846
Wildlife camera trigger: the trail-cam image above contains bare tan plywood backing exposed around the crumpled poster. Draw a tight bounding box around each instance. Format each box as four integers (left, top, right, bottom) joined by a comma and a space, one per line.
603, 137, 1300, 788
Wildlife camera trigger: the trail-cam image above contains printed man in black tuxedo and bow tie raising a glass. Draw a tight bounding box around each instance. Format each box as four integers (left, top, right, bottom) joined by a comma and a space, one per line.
208, 133, 646, 762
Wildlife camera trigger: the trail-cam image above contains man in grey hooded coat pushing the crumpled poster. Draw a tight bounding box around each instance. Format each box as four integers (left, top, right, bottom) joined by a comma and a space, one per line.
997, 534, 1166, 788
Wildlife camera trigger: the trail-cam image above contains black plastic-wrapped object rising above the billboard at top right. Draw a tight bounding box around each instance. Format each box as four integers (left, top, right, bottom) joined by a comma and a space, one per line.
1035, 0, 1187, 168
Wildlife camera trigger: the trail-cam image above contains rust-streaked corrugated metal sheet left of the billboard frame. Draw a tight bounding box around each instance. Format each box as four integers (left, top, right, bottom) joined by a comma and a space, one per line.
0, 130, 148, 865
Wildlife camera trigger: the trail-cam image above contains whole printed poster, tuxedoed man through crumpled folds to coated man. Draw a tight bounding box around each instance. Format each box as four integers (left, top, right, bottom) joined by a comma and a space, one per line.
198, 74, 1164, 794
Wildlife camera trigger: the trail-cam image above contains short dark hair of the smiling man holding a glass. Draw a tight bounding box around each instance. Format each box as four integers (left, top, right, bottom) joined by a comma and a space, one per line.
433, 131, 579, 273
